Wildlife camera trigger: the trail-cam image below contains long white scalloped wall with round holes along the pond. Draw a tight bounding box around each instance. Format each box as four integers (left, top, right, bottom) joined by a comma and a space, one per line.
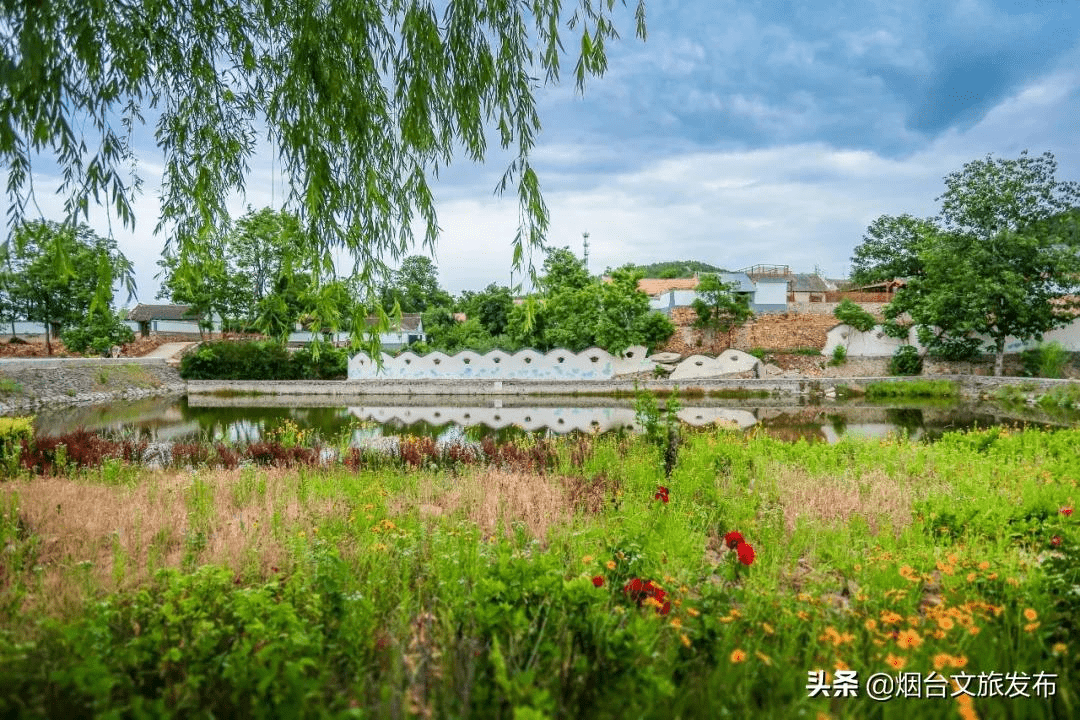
349, 345, 656, 380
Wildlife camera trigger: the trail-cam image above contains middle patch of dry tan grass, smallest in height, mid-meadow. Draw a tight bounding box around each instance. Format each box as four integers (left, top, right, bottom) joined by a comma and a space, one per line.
390, 467, 595, 540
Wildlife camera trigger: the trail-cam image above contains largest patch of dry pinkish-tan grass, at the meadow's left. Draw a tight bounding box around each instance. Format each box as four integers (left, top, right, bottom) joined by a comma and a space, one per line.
0, 468, 348, 614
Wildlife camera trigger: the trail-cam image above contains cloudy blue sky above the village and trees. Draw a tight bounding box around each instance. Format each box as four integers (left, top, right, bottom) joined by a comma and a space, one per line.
8, 0, 1080, 307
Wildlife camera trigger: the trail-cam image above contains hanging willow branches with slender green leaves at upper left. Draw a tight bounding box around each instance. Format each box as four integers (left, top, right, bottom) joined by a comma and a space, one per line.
0, 0, 645, 349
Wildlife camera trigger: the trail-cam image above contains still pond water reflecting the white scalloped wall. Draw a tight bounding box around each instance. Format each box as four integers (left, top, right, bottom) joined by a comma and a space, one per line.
23, 396, 1077, 444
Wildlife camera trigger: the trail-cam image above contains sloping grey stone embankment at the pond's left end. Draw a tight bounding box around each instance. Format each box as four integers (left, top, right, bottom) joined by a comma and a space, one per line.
0, 357, 187, 415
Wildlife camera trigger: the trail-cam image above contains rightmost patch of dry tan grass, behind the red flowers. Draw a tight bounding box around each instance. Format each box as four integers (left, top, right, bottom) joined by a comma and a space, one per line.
773, 466, 931, 534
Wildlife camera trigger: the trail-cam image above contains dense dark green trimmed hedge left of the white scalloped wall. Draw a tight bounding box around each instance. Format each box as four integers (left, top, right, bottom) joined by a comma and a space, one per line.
180, 340, 349, 380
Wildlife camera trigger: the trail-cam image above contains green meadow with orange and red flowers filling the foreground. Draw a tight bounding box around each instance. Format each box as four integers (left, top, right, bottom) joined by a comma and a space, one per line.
0, 429, 1080, 720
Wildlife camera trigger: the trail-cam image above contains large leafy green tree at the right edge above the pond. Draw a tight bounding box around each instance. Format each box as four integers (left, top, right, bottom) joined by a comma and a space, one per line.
852, 151, 1080, 375
